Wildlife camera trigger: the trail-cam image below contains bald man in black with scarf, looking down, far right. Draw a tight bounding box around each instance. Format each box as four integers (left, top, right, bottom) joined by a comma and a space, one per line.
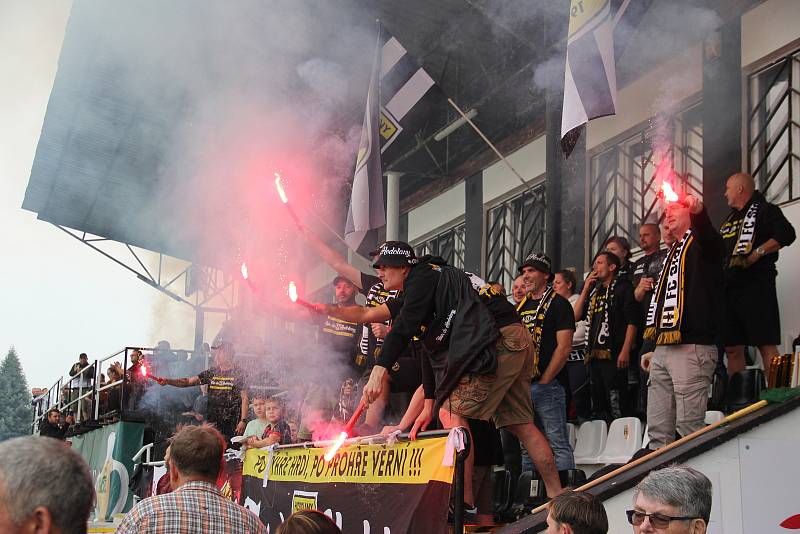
720, 173, 795, 376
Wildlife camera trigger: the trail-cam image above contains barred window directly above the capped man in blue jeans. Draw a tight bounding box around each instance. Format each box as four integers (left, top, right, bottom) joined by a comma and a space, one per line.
486, 183, 546, 294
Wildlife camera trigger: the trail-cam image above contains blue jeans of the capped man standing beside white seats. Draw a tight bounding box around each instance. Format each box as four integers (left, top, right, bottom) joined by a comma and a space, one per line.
522, 380, 575, 471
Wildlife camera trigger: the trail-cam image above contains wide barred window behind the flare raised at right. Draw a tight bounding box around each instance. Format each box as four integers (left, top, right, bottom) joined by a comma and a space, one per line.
586, 104, 703, 255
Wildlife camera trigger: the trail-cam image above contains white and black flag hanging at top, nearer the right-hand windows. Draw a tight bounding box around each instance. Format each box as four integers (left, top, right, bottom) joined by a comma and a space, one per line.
561, 0, 617, 151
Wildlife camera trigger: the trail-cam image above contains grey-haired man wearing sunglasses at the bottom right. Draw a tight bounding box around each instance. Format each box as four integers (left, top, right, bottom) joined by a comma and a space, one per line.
626, 465, 712, 534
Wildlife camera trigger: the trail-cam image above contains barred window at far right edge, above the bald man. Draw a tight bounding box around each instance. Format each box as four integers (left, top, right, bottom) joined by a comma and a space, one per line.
747, 50, 800, 204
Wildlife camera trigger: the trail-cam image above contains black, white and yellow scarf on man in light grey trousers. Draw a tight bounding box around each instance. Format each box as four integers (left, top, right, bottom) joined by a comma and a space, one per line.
644, 229, 694, 345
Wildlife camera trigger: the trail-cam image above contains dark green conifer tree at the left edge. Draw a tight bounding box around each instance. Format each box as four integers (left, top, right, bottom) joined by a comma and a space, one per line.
0, 346, 32, 441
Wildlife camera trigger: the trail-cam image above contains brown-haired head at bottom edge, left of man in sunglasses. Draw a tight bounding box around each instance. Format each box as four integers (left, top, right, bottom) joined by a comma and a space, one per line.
545, 491, 608, 534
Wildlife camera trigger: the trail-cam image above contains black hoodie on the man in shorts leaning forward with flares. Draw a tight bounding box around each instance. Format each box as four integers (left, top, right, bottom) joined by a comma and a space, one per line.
377, 256, 500, 406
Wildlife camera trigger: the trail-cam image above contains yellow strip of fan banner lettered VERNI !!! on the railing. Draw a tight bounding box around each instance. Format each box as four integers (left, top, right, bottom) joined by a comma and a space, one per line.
243, 437, 454, 484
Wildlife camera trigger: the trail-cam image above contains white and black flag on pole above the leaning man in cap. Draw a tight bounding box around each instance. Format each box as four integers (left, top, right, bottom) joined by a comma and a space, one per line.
345, 26, 440, 253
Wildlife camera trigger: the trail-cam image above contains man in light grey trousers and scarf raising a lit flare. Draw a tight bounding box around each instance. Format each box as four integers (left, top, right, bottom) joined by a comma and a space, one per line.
642, 195, 724, 449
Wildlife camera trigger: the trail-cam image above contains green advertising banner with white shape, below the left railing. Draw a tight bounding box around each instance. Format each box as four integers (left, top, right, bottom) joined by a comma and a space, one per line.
72, 422, 144, 521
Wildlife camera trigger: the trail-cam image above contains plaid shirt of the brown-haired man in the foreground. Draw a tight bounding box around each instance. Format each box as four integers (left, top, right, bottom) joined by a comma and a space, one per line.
117, 481, 267, 534
